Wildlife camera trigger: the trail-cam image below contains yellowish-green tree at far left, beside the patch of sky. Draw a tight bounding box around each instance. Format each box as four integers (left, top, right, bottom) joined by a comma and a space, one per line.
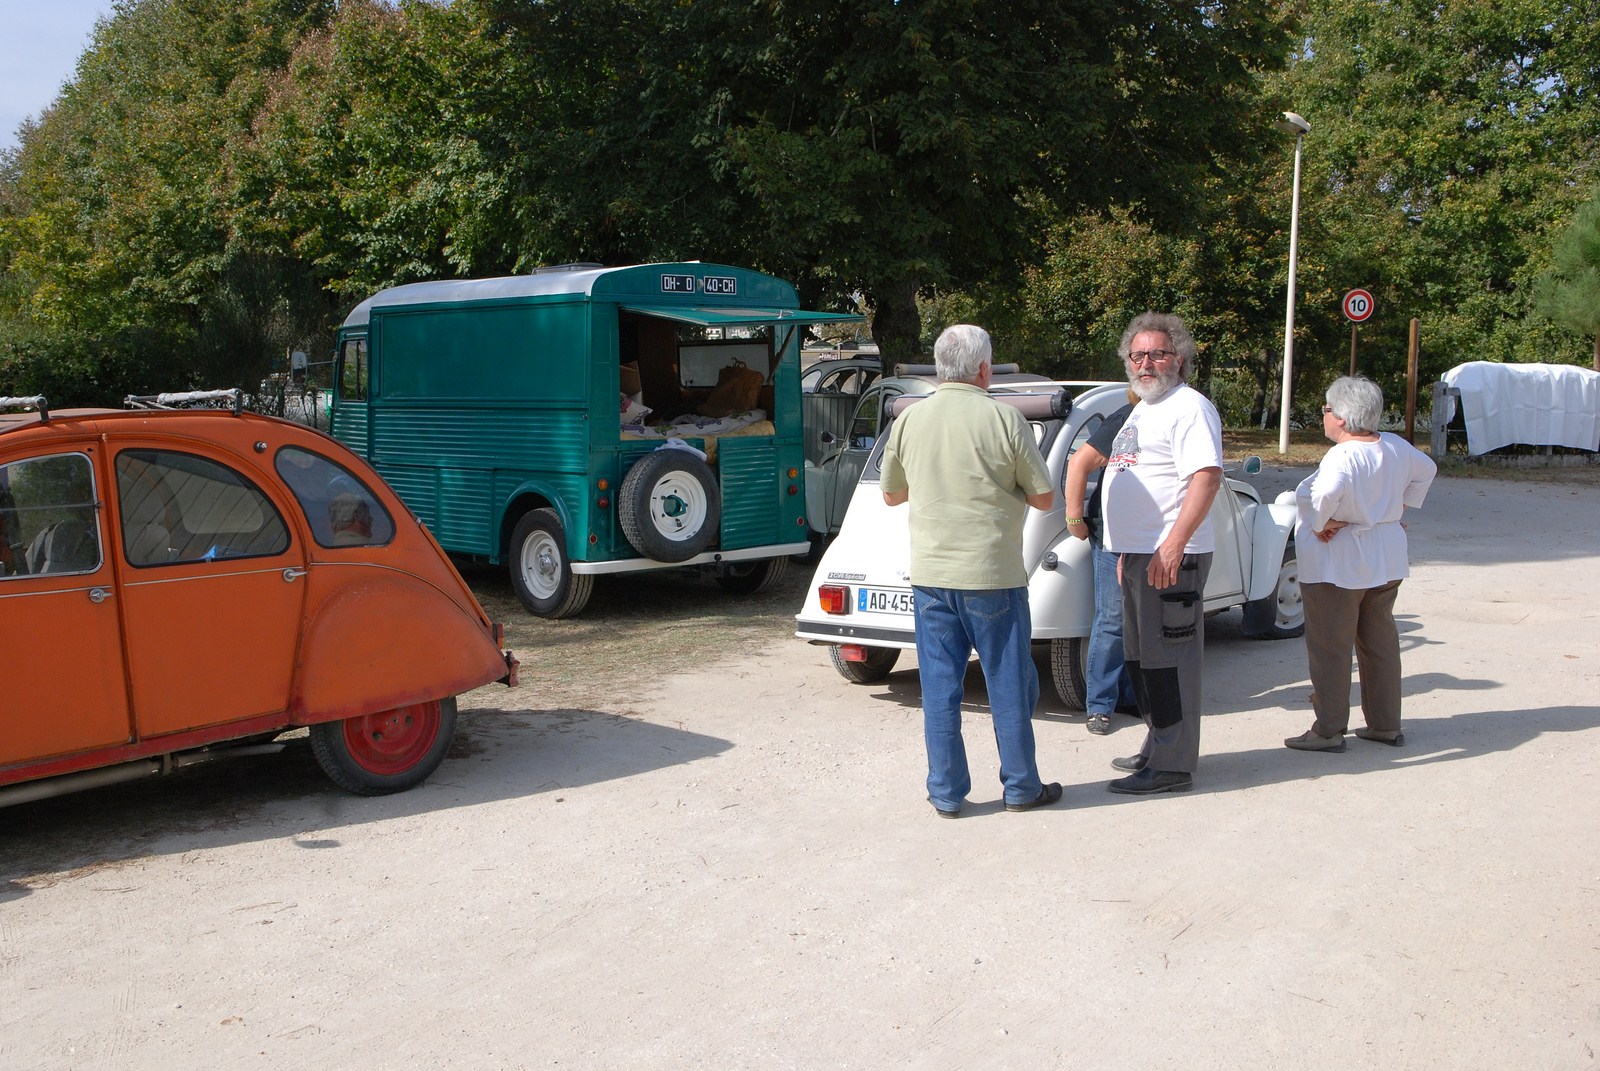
0, 0, 333, 402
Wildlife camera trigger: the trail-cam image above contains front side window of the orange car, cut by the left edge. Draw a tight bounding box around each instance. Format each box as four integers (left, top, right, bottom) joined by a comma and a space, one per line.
0, 453, 102, 576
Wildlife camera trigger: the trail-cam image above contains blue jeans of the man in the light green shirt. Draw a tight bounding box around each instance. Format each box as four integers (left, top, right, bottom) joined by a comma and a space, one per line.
912, 586, 1045, 810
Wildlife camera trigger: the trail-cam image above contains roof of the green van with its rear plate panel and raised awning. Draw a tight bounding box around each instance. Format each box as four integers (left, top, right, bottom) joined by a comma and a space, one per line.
344, 261, 862, 328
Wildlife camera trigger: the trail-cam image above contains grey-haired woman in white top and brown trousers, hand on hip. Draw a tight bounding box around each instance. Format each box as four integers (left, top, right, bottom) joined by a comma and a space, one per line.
1283, 376, 1437, 751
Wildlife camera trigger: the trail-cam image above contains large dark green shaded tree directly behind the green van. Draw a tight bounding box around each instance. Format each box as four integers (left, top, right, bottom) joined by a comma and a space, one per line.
467, 0, 1285, 362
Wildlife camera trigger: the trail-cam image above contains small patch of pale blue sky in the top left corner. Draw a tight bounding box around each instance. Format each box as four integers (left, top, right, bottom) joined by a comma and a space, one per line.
0, 0, 112, 149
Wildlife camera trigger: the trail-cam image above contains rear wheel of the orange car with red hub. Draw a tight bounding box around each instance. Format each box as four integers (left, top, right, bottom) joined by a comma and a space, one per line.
310, 696, 456, 796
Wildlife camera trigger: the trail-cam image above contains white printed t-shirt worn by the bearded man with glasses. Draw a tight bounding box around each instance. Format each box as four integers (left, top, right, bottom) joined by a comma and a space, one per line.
1101, 383, 1222, 554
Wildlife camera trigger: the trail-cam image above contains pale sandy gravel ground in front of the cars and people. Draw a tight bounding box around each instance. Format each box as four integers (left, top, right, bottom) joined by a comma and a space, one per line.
0, 471, 1600, 1071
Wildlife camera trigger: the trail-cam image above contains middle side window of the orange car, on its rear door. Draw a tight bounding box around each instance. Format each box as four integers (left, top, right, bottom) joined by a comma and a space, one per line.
117, 450, 290, 568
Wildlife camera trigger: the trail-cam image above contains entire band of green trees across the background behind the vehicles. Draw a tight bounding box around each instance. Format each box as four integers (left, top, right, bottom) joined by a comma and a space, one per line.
0, 0, 1600, 426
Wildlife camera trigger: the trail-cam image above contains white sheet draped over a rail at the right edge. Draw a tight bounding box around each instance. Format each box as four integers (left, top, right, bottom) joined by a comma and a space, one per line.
1445, 360, 1600, 453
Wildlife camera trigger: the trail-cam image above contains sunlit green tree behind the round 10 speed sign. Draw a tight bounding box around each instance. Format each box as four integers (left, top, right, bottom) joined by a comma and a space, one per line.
1264, 0, 1600, 409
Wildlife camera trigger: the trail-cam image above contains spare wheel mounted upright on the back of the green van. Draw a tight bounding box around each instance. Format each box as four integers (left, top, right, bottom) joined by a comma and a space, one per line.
618, 450, 722, 562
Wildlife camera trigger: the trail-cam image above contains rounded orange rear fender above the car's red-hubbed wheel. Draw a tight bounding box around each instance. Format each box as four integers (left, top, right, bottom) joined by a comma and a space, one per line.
290, 565, 506, 725
